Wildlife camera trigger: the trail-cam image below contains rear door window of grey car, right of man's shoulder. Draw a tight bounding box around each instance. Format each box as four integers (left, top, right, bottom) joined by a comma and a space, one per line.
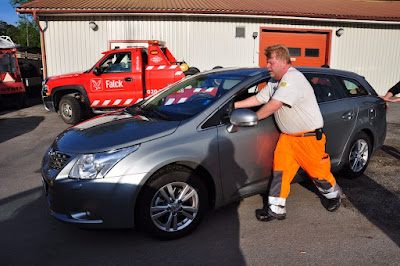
305, 73, 344, 103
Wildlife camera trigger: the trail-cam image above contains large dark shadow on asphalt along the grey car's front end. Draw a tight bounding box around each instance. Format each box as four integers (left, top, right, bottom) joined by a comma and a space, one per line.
0, 188, 245, 265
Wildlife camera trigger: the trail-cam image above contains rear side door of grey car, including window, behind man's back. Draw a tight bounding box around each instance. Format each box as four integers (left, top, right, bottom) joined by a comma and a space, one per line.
304, 73, 358, 166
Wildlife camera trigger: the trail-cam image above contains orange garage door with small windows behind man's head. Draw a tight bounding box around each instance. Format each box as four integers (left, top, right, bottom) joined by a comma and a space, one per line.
259, 29, 331, 67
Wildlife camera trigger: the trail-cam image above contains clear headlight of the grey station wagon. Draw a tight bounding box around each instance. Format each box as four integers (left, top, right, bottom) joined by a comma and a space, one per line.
68, 145, 139, 179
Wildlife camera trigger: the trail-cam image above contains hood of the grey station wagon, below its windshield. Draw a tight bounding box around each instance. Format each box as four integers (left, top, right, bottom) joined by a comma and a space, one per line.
53, 110, 180, 153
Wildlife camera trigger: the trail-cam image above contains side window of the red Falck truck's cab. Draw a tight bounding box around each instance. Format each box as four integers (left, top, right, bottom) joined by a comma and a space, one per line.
99, 53, 131, 73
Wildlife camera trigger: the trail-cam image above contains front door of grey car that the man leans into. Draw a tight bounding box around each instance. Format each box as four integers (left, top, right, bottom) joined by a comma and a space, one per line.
217, 80, 279, 201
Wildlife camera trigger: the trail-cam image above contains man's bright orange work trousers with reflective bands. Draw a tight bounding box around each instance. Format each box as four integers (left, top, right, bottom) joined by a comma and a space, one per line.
268, 133, 339, 214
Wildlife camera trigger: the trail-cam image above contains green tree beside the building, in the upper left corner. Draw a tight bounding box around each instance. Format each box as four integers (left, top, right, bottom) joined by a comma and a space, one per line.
8, 0, 40, 47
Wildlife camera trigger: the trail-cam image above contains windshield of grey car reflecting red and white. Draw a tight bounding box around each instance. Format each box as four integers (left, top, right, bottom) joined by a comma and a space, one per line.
127, 72, 249, 120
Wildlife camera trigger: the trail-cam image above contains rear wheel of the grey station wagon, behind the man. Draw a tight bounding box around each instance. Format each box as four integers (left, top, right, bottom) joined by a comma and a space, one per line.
339, 132, 372, 179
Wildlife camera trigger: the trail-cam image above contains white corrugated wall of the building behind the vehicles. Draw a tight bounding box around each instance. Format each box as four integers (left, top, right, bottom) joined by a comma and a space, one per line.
40, 16, 400, 94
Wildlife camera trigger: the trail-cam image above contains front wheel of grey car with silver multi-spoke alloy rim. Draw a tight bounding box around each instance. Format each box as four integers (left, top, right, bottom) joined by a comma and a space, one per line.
136, 167, 208, 240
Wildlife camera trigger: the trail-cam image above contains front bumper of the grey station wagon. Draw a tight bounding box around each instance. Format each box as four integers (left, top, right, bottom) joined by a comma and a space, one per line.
42, 164, 143, 228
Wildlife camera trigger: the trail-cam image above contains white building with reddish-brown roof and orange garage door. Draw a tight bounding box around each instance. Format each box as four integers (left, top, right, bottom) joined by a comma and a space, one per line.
17, 0, 400, 94
